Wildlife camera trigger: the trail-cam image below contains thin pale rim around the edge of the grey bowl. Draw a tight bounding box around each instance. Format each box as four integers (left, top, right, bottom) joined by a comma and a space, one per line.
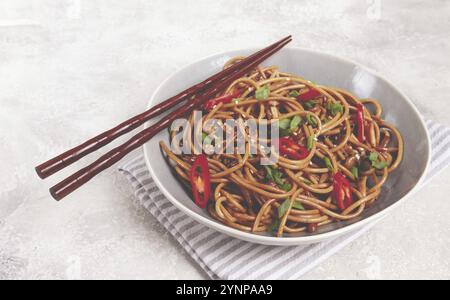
143, 47, 431, 246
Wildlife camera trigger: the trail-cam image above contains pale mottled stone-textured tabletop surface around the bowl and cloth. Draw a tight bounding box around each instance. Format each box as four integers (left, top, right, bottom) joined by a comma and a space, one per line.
0, 0, 450, 279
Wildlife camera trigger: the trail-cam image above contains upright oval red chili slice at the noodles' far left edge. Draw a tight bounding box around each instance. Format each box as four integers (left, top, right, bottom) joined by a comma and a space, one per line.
189, 154, 211, 208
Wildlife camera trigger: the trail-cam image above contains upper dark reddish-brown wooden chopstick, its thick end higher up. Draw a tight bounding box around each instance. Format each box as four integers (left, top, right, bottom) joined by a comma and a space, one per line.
35, 36, 291, 179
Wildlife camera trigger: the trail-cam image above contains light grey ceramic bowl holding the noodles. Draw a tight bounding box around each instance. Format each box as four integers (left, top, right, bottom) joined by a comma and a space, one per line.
144, 48, 430, 246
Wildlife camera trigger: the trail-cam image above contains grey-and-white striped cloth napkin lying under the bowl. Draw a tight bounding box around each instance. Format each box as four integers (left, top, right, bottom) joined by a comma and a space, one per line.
119, 121, 450, 279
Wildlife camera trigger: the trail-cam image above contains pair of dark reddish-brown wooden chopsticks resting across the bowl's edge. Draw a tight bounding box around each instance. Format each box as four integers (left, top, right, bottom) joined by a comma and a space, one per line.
36, 36, 292, 200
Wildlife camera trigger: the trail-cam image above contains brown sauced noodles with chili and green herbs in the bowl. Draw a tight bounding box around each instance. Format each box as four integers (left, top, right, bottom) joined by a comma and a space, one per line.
160, 57, 403, 236
